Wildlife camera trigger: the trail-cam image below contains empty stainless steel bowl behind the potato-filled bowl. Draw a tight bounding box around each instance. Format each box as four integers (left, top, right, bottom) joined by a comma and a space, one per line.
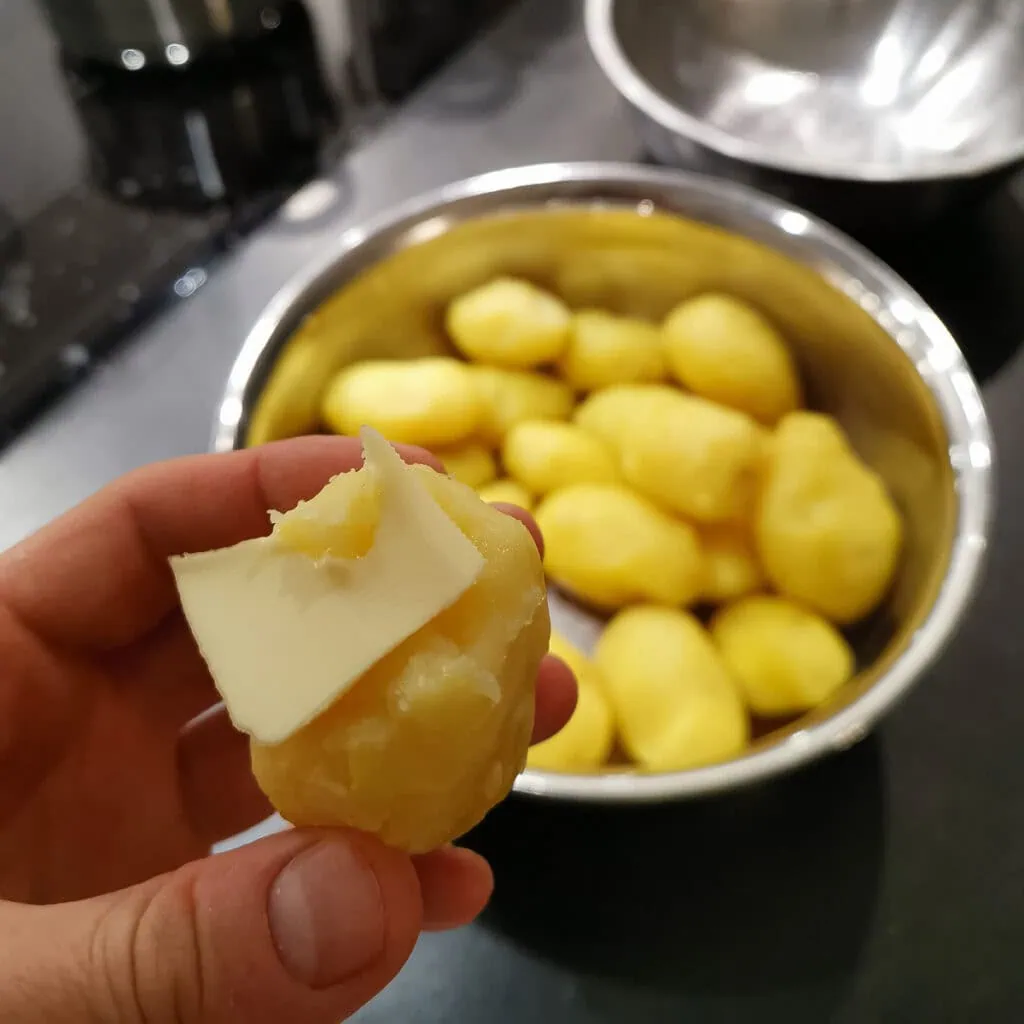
586, 0, 1024, 230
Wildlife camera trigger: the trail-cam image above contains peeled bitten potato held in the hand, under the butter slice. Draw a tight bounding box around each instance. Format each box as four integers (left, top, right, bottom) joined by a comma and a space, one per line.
252, 467, 549, 853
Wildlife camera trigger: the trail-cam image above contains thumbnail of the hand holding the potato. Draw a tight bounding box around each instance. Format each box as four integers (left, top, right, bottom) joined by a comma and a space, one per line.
267, 839, 384, 988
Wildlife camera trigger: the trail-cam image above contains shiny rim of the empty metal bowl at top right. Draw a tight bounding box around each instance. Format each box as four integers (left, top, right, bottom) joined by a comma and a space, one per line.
584, 0, 1024, 184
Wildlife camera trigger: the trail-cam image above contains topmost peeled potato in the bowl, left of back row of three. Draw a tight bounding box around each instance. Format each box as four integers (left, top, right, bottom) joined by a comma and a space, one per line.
445, 278, 571, 370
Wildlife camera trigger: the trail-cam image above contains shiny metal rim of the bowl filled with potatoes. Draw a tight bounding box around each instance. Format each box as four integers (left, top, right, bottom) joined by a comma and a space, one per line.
211, 162, 995, 803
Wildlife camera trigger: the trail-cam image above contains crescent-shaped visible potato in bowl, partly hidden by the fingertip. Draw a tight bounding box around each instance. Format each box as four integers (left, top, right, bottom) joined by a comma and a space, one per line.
526, 633, 615, 772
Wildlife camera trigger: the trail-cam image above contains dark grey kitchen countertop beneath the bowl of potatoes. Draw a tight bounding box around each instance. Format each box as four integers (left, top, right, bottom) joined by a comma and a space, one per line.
6, 0, 1024, 1024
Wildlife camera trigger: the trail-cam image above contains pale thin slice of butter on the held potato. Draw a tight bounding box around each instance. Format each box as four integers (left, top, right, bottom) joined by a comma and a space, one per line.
170, 428, 483, 743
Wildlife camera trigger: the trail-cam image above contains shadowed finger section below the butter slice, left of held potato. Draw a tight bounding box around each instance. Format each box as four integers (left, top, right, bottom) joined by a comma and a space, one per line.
177, 707, 273, 845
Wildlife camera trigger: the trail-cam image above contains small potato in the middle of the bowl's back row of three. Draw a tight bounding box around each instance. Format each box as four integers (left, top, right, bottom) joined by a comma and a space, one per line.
559, 309, 666, 391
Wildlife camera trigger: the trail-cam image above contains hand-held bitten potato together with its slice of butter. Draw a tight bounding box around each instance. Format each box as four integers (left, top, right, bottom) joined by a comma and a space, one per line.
171, 428, 550, 852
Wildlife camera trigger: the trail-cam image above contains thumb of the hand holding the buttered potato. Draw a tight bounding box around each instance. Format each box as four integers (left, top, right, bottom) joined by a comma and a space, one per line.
0, 829, 422, 1024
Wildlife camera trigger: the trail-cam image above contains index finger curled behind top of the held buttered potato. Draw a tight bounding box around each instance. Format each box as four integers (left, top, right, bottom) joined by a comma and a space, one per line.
0, 436, 439, 650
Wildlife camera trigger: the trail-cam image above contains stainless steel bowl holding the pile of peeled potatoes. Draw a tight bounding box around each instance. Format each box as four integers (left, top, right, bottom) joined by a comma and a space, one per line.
213, 164, 992, 801
